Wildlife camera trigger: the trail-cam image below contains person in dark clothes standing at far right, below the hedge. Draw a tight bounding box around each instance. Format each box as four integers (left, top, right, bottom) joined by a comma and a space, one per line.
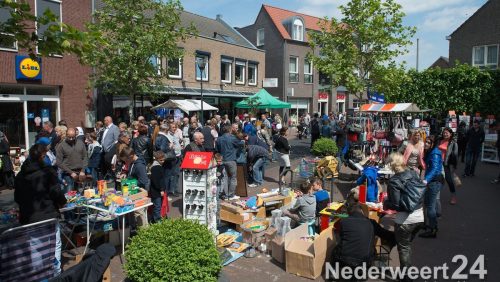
463, 120, 485, 177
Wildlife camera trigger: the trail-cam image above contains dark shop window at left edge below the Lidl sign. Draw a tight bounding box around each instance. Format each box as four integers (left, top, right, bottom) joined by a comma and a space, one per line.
0, 102, 26, 148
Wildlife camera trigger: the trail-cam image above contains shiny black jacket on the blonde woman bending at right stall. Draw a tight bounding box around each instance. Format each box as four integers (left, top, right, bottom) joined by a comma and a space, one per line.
384, 169, 425, 212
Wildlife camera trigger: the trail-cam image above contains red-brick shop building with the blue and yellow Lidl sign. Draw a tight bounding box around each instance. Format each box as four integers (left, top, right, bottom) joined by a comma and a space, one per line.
0, 0, 92, 148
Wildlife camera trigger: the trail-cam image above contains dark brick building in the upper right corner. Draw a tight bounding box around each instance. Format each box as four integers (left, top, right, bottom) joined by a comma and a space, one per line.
447, 0, 500, 69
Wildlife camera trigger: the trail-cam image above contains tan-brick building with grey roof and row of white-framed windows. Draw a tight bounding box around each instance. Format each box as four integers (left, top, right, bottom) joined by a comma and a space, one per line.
106, 11, 266, 119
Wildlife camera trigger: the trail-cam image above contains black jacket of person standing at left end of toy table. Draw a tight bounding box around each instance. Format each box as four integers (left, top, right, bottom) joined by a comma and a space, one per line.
14, 160, 66, 224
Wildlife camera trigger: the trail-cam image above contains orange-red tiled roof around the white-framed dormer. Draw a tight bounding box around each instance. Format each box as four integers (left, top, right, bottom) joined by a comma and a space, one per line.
262, 5, 322, 39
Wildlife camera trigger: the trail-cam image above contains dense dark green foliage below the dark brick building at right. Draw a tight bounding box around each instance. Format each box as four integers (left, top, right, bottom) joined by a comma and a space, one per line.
386, 64, 493, 115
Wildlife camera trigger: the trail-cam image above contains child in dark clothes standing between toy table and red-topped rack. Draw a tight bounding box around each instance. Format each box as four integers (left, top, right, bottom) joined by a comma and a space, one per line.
149, 151, 165, 222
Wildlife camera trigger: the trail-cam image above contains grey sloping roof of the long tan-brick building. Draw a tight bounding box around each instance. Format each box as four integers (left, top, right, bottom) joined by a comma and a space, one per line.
180, 11, 257, 49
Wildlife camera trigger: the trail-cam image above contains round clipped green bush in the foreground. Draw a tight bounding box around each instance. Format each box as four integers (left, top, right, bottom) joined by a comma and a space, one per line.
125, 219, 222, 281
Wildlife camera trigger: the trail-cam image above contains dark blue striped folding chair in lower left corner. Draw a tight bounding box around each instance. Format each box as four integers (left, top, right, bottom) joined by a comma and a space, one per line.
0, 218, 57, 281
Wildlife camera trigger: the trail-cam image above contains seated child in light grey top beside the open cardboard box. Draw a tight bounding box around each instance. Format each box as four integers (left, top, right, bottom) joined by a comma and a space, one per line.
283, 182, 316, 226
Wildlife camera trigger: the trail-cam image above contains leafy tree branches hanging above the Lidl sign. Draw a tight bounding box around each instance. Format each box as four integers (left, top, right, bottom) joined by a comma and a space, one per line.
0, 0, 87, 59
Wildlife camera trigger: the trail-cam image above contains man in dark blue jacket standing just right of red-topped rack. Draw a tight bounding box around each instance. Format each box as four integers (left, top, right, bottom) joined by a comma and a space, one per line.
215, 125, 243, 199
